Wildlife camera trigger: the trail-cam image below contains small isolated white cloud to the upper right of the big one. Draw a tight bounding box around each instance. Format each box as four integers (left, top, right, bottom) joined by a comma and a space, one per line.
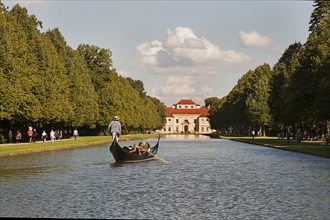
238, 30, 273, 48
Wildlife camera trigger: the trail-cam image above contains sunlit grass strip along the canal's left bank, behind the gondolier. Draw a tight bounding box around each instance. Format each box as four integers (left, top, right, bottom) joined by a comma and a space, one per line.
0, 134, 158, 157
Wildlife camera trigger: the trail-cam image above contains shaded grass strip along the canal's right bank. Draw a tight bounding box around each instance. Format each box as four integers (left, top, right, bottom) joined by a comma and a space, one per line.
220, 136, 330, 158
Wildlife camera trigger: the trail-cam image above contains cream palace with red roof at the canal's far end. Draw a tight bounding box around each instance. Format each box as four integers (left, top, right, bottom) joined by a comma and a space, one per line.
160, 100, 213, 134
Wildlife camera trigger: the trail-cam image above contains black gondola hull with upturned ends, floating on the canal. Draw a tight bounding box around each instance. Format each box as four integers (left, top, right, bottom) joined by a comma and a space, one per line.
110, 135, 160, 162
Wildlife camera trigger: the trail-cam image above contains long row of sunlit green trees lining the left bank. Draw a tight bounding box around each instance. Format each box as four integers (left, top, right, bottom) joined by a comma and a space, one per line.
0, 1, 165, 143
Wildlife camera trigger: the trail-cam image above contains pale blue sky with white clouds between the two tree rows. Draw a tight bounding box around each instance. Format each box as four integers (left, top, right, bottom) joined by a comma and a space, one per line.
2, 0, 314, 106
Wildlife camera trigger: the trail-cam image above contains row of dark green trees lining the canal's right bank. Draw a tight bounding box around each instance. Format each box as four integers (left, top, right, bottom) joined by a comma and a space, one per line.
205, 1, 330, 138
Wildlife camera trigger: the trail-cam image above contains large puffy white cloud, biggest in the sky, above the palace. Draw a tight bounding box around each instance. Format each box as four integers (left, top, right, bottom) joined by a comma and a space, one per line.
134, 27, 251, 75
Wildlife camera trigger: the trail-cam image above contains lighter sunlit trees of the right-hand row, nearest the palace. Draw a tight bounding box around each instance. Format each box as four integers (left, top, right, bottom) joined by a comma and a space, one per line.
211, 64, 271, 133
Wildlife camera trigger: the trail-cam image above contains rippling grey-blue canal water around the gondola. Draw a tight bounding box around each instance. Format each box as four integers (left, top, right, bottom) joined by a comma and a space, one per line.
0, 136, 330, 220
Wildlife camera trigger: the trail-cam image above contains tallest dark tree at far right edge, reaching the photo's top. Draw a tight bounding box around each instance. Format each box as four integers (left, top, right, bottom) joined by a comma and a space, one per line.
288, 1, 330, 131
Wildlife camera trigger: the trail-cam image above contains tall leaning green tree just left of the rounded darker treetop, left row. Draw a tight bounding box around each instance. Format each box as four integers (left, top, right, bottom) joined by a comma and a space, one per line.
46, 28, 99, 127
